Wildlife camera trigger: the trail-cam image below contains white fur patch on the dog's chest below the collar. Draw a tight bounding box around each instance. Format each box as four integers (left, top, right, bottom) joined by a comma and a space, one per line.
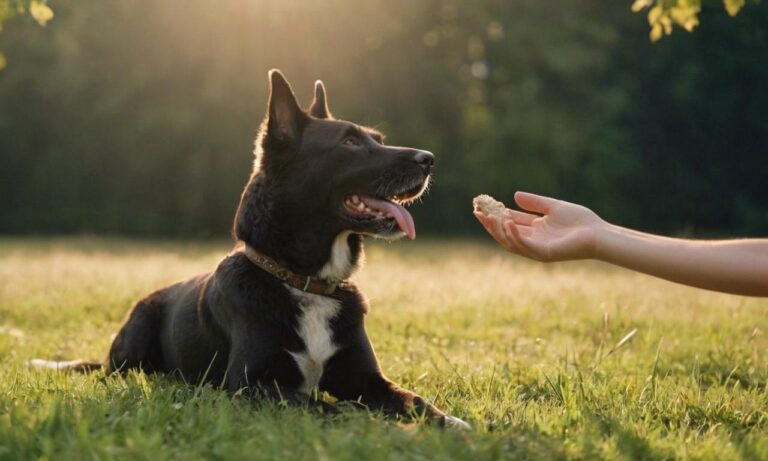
288, 287, 341, 394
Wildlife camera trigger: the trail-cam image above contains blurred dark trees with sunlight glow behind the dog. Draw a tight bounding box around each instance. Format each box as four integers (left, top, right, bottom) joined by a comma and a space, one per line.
0, 0, 768, 238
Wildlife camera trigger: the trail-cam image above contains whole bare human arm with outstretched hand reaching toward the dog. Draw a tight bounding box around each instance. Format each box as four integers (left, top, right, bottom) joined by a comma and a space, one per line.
475, 192, 768, 296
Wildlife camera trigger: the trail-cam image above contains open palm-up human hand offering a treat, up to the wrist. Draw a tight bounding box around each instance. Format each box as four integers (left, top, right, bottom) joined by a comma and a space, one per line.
475, 192, 609, 262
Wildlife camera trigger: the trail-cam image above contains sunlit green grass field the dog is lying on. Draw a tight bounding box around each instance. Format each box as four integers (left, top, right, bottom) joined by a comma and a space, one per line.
0, 239, 768, 461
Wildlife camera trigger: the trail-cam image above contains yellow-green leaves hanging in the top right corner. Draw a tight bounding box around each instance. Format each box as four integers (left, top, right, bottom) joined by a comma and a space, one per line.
631, 0, 760, 42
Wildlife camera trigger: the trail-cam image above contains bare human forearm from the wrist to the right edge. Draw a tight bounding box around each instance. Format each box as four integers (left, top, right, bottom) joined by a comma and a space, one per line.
595, 225, 768, 296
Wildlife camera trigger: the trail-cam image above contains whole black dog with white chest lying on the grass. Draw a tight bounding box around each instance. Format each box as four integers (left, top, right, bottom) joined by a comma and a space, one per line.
38, 70, 466, 427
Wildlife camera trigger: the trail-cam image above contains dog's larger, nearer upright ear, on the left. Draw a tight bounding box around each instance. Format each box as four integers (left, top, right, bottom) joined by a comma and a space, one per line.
267, 69, 306, 140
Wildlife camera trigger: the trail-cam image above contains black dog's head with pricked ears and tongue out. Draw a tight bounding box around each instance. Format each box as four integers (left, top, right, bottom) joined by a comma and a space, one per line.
235, 70, 434, 268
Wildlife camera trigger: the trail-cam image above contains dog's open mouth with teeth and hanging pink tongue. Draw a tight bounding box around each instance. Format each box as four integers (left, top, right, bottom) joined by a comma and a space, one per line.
344, 182, 422, 240
